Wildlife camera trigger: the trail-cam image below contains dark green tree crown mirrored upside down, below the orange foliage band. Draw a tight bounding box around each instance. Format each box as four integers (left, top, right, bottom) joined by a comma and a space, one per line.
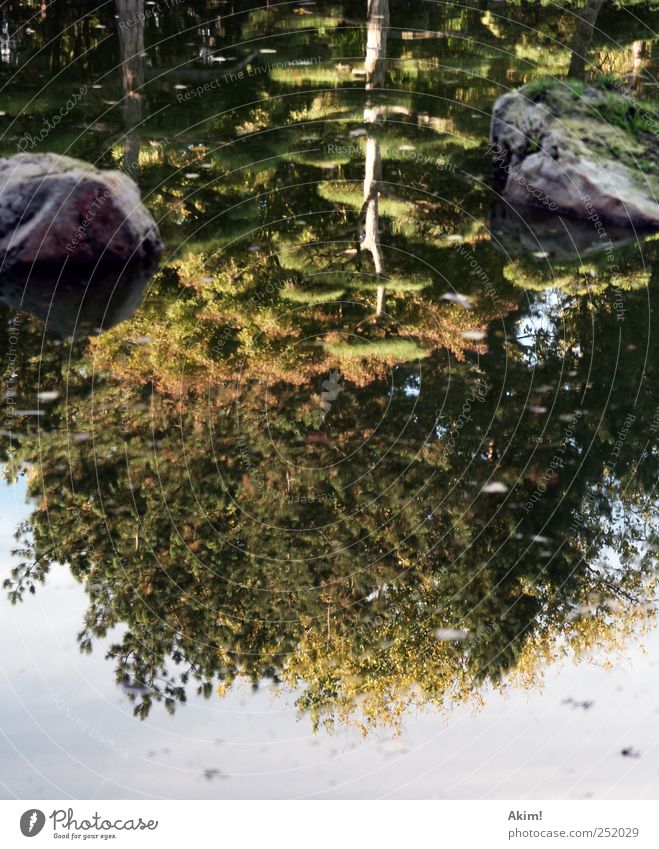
2, 282, 657, 724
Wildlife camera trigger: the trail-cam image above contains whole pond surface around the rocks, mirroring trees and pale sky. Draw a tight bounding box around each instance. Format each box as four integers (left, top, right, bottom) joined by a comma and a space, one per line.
0, 2, 659, 798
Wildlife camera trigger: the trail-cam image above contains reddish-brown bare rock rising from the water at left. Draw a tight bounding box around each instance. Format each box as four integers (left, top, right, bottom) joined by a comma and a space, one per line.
0, 153, 162, 272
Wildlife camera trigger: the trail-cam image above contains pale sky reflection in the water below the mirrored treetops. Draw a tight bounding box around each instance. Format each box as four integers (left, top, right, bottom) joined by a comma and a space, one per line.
0, 470, 659, 799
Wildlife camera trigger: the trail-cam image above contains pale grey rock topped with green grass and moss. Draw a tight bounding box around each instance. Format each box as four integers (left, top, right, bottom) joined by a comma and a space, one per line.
491, 80, 659, 229
